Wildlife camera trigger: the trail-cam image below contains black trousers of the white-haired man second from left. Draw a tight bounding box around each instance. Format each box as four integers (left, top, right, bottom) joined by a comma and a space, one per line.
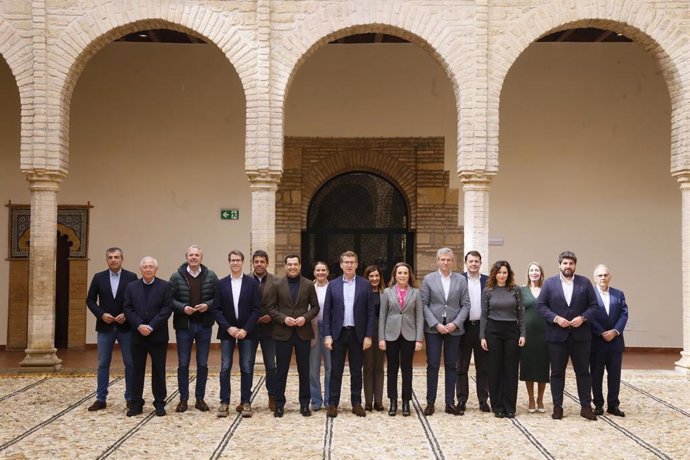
132, 338, 168, 409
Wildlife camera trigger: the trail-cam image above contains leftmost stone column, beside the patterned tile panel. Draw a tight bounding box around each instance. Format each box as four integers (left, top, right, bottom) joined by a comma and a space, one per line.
19, 172, 63, 372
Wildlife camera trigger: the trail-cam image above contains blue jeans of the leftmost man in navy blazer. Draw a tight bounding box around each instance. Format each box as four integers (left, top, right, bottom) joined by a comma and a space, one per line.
96, 326, 134, 402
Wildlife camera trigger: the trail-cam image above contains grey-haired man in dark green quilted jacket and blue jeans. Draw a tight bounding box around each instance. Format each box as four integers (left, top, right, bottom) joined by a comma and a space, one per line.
170, 245, 218, 412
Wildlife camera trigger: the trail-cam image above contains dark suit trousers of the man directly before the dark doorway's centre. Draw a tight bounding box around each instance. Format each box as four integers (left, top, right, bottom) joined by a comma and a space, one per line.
328, 328, 364, 406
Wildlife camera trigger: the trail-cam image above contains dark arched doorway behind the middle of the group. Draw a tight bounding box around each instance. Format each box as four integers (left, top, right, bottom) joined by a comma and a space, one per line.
302, 172, 414, 281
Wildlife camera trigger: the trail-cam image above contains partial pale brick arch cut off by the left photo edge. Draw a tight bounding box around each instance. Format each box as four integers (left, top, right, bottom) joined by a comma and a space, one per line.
0, 18, 34, 169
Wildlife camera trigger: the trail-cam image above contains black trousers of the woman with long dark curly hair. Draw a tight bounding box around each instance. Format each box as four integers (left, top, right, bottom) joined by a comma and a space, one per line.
486, 319, 520, 414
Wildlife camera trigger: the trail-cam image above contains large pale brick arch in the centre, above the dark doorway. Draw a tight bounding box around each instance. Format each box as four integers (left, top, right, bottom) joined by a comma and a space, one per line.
270, 0, 468, 173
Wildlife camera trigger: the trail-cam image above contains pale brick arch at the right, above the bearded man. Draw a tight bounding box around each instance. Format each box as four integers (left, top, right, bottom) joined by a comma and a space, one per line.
484, 0, 690, 174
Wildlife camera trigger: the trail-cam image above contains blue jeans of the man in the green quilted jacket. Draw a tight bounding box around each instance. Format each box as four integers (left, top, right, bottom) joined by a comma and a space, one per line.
176, 321, 212, 401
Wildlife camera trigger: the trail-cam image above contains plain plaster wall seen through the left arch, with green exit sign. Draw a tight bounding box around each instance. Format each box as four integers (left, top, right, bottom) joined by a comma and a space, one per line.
59, 43, 246, 343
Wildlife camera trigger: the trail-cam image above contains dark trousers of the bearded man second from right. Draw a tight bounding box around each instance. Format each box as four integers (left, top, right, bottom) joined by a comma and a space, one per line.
547, 334, 592, 407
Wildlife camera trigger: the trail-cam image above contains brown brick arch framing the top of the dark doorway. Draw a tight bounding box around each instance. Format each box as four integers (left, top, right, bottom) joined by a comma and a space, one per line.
301, 152, 417, 228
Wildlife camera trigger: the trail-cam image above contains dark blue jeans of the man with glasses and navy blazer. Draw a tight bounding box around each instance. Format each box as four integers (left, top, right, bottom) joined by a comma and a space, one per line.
220, 339, 258, 404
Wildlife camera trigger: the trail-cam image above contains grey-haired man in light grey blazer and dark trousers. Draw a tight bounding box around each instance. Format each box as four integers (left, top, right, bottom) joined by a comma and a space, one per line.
421, 248, 471, 415
